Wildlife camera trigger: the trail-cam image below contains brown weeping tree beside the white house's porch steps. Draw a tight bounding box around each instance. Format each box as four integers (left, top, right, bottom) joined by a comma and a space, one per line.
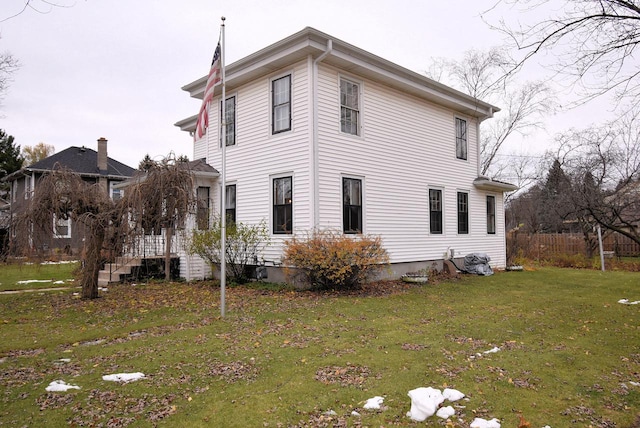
117, 155, 195, 280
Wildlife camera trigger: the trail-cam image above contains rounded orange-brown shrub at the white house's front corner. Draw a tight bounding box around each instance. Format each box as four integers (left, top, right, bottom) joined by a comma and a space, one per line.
284, 230, 389, 289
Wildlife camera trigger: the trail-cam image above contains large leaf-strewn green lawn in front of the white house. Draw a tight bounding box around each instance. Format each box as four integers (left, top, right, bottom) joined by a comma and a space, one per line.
0, 268, 640, 428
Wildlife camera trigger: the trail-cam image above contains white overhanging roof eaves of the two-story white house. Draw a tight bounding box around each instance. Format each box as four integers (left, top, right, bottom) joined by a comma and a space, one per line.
175, 27, 500, 131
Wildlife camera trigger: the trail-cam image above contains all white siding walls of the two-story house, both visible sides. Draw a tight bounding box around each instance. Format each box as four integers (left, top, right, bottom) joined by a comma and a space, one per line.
191, 60, 506, 277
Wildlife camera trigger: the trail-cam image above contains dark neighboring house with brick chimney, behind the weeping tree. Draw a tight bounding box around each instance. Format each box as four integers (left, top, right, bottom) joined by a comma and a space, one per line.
4, 138, 136, 252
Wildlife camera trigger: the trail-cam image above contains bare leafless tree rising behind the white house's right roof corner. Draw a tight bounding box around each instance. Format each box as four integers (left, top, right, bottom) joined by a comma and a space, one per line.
427, 48, 556, 177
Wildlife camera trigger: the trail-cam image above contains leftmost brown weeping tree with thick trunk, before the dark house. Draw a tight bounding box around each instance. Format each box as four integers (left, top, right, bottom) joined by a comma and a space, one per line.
13, 167, 118, 299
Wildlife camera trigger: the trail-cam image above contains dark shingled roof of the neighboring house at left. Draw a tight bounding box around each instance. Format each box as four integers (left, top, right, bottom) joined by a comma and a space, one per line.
5, 146, 136, 181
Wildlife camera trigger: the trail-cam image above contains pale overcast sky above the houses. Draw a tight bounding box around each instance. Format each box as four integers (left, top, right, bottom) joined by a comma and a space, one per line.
0, 0, 616, 168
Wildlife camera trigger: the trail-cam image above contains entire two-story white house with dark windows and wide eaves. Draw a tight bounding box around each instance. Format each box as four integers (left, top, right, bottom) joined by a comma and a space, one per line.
176, 28, 516, 279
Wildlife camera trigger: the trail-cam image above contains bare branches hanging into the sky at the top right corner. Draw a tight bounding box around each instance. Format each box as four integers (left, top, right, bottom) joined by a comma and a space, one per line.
486, 0, 640, 105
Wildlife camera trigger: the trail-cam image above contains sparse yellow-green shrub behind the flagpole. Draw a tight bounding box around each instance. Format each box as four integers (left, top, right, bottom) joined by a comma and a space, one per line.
188, 219, 269, 283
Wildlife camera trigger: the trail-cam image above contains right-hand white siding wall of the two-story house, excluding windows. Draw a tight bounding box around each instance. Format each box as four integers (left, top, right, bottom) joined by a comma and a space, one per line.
312, 66, 505, 267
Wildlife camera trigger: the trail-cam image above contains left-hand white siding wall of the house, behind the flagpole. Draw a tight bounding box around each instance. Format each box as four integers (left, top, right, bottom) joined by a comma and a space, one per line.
199, 61, 311, 261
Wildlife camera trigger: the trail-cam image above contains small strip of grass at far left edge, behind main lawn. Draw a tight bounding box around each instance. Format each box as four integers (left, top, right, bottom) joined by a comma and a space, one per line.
0, 262, 78, 291
